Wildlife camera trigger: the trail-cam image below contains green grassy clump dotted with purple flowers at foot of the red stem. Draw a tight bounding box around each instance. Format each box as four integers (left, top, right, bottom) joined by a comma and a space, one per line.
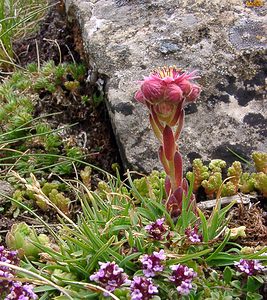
1, 169, 267, 300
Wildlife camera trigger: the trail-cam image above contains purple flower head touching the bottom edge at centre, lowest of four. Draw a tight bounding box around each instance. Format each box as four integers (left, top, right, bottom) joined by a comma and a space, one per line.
131, 276, 158, 300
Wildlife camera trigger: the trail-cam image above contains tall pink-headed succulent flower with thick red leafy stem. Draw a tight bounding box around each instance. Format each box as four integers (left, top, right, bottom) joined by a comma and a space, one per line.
135, 66, 201, 218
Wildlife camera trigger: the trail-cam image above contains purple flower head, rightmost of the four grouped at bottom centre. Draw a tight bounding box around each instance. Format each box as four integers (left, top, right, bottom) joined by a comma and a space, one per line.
170, 264, 197, 295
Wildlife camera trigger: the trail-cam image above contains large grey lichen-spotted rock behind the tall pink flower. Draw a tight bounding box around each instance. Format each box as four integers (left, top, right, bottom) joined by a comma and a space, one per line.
66, 0, 267, 172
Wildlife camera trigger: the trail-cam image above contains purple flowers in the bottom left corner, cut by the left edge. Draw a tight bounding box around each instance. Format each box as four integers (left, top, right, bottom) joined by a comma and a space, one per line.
0, 246, 38, 300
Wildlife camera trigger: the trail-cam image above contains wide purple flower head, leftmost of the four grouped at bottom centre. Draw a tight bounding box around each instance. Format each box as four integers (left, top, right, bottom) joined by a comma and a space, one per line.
90, 262, 130, 292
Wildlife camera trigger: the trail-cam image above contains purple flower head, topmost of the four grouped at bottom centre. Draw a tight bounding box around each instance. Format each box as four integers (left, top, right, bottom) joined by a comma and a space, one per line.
140, 249, 166, 277
